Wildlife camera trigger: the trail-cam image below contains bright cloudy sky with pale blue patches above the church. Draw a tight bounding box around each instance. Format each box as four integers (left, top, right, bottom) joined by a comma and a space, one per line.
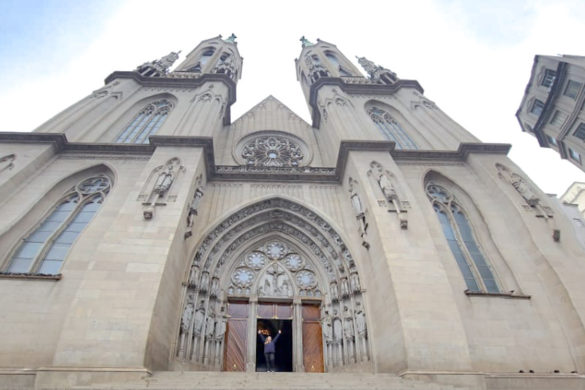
0, 0, 585, 195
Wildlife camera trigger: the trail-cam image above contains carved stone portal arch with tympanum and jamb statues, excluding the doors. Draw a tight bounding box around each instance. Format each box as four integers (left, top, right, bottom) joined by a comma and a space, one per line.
176, 198, 369, 369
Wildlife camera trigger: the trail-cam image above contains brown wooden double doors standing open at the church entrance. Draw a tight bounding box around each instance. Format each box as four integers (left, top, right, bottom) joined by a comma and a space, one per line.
223, 301, 324, 372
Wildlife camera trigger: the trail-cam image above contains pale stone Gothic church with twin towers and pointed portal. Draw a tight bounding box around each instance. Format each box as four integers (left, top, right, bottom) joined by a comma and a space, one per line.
0, 35, 585, 389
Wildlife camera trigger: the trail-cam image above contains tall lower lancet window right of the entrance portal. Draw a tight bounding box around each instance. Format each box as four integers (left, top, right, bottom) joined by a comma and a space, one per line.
426, 183, 500, 293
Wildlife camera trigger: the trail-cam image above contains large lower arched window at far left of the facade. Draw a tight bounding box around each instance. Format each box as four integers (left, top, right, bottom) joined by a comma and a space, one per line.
5, 176, 111, 275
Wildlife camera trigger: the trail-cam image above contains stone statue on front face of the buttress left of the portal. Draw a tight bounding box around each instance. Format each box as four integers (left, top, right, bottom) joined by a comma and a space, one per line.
138, 157, 185, 220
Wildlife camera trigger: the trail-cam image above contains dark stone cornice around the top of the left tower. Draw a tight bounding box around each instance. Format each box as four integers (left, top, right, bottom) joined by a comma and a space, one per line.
105, 71, 236, 126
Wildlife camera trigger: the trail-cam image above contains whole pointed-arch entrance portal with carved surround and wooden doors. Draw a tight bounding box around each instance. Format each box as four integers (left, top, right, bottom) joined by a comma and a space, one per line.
176, 198, 370, 372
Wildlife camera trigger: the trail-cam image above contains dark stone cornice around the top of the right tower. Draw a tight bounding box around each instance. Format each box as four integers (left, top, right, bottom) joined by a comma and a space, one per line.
309, 77, 424, 128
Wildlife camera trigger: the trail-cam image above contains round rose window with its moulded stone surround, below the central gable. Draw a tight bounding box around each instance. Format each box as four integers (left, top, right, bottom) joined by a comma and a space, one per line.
234, 131, 311, 168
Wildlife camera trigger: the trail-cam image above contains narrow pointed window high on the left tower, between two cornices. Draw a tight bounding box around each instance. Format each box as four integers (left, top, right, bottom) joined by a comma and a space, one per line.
116, 99, 173, 144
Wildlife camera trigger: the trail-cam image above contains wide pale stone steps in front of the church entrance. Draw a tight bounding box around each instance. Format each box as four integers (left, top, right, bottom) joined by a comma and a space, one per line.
70, 371, 469, 390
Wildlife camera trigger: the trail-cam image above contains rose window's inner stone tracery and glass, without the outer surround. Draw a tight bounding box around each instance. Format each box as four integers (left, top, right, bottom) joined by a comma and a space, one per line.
241, 135, 305, 167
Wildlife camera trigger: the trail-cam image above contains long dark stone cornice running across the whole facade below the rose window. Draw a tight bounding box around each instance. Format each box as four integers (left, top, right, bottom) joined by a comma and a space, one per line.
0, 132, 511, 183
